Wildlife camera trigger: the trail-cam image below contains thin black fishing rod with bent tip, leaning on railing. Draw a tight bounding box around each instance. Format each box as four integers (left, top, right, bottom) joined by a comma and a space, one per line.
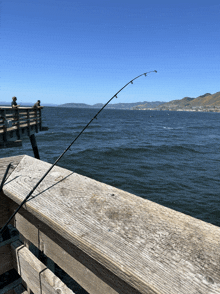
0, 70, 157, 234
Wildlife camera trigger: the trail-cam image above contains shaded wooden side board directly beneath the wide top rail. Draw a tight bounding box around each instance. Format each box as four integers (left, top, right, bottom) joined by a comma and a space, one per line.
15, 213, 122, 294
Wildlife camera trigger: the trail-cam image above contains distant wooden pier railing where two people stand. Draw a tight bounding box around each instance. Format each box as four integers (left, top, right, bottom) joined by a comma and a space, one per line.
0, 107, 42, 142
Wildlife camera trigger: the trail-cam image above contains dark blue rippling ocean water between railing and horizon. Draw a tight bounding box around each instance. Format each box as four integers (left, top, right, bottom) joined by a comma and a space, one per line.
0, 107, 220, 226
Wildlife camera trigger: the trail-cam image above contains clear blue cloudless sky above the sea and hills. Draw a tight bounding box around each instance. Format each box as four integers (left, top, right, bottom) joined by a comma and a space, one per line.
0, 0, 220, 105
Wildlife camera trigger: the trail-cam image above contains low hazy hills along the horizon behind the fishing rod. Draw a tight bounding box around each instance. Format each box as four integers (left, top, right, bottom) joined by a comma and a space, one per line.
58, 101, 164, 109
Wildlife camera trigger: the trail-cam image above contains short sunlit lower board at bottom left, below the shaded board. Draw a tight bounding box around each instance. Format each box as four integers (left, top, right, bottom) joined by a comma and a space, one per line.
11, 241, 73, 294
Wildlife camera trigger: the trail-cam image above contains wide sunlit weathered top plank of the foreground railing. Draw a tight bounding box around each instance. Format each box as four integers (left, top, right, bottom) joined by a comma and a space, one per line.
3, 156, 220, 294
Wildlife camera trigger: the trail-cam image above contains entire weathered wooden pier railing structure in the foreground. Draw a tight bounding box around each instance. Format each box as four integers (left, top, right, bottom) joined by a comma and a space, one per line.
0, 155, 220, 294
